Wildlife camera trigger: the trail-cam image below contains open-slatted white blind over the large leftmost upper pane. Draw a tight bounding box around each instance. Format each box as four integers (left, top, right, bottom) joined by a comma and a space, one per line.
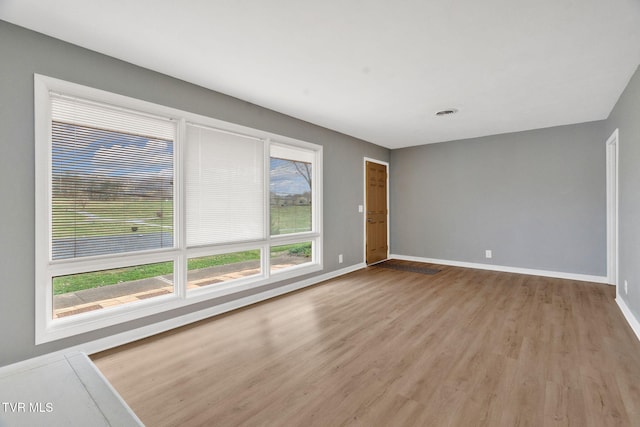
50, 94, 176, 260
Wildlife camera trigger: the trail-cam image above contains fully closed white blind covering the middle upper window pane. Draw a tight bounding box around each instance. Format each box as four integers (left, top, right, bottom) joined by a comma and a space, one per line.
185, 124, 265, 246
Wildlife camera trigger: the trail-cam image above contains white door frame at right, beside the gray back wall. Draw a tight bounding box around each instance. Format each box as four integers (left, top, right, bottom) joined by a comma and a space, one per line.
606, 129, 620, 297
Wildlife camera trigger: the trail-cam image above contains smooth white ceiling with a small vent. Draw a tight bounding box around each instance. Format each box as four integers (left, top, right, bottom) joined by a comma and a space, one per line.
0, 0, 640, 148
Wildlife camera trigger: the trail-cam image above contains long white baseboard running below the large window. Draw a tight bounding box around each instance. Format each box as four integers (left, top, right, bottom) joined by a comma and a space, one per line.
0, 263, 366, 376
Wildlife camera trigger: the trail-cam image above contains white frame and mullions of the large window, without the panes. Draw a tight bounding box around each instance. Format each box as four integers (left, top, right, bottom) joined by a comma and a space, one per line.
34, 74, 323, 345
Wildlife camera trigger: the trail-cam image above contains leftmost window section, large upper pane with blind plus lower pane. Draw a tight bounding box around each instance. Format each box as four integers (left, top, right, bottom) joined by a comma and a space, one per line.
49, 92, 177, 319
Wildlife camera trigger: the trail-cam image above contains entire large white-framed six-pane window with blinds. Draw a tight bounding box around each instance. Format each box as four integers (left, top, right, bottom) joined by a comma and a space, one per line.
35, 76, 322, 343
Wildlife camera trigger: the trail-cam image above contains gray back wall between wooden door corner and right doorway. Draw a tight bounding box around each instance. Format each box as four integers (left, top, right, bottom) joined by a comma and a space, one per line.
390, 121, 606, 276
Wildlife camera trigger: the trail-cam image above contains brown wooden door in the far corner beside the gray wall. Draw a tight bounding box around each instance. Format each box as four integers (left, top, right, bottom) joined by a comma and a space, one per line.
365, 162, 388, 264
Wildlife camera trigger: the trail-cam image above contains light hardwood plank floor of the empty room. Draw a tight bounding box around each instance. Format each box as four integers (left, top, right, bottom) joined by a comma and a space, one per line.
92, 266, 640, 427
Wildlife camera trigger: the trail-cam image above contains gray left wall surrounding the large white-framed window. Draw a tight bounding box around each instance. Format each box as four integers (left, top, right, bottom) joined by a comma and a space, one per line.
0, 21, 389, 366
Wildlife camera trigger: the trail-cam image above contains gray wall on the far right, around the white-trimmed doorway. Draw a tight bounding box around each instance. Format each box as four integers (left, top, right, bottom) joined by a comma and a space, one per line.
606, 69, 640, 328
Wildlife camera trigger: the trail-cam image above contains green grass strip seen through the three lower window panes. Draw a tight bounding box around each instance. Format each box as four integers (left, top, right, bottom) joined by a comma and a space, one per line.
53, 242, 311, 295
